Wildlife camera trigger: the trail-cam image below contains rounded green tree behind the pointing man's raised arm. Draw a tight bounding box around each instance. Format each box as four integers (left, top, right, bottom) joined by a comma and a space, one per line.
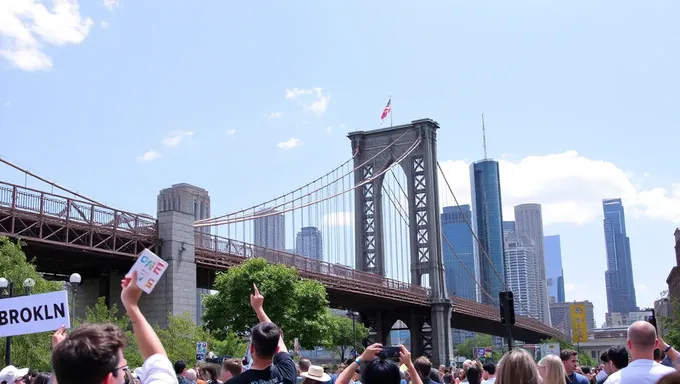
203, 258, 329, 348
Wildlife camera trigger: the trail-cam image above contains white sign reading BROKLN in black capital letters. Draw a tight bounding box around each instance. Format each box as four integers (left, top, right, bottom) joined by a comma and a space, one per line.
0, 291, 71, 337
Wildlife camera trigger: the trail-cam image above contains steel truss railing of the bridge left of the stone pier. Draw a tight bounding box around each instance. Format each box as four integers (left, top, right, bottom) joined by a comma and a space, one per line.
0, 182, 156, 236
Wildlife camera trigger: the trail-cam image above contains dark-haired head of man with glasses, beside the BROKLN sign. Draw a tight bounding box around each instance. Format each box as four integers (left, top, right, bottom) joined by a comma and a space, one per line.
52, 324, 128, 384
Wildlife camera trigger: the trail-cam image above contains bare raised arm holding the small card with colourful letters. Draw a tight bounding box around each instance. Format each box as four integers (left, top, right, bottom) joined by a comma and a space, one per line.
120, 271, 167, 360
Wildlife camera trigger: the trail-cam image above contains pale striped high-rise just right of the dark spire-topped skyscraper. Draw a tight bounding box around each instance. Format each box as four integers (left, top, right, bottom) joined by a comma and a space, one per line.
504, 231, 540, 319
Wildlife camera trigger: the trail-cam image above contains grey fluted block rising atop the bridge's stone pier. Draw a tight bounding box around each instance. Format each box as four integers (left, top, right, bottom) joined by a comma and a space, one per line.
158, 183, 210, 233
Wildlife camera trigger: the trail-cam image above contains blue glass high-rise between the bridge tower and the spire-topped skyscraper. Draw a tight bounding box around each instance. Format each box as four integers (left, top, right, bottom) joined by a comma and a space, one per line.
441, 204, 479, 301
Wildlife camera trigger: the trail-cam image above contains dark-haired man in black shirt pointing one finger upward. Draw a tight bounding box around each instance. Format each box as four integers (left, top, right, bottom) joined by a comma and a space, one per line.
227, 284, 297, 384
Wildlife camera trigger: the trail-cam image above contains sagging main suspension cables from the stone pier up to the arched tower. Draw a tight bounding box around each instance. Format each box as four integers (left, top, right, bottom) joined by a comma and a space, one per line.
195, 131, 407, 227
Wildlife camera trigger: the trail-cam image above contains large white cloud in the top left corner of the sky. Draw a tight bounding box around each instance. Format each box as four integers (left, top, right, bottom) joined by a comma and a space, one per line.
0, 0, 94, 71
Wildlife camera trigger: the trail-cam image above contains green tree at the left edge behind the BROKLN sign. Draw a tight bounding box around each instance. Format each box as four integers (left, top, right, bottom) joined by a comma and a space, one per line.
0, 236, 63, 370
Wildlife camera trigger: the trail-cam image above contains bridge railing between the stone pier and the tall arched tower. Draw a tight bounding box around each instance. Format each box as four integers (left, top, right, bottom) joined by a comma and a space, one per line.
196, 232, 428, 297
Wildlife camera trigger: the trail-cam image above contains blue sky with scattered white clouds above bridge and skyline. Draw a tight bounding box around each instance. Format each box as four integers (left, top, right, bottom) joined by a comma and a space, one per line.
0, 0, 680, 323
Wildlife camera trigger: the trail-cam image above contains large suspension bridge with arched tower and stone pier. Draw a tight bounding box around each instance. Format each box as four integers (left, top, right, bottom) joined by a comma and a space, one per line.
0, 119, 564, 363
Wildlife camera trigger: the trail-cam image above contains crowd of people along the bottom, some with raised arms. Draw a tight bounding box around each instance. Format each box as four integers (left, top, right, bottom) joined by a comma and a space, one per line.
0, 273, 680, 384
